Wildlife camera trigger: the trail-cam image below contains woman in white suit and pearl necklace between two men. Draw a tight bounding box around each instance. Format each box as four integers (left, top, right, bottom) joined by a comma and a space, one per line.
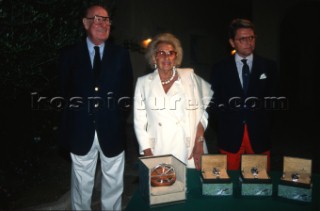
134, 33, 213, 169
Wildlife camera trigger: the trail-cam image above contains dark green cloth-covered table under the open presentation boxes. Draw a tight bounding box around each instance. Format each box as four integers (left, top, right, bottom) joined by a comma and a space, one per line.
125, 169, 320, 211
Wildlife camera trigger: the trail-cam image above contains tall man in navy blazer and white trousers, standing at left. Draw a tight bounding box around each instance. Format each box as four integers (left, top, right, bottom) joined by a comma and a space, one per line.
59, 5, 133, 210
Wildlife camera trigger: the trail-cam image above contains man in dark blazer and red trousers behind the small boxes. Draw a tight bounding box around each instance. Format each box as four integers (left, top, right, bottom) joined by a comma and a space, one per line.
210, 19, 277, 170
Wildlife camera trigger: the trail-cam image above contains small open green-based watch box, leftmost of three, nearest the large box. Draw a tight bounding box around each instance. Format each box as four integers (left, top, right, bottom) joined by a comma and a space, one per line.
200, 155, 233, 196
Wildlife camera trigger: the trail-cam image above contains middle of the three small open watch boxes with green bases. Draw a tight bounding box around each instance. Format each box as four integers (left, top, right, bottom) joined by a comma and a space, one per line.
239, 154, 272, 196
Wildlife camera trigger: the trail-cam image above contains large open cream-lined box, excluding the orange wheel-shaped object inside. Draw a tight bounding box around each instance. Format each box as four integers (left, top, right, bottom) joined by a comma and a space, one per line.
139, 155, 187, 205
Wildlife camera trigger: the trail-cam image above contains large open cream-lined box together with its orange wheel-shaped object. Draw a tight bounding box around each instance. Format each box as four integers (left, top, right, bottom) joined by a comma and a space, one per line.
139, 155, 187, 206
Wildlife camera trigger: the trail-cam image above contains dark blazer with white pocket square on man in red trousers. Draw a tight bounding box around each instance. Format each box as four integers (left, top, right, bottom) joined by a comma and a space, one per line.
210, 55, 276, 153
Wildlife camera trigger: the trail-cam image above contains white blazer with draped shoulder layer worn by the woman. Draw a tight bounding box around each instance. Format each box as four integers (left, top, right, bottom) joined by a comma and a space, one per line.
133, 68, 213, 168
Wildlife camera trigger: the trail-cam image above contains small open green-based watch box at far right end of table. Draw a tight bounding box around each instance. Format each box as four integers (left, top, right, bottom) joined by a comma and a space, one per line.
278, 156, 312, 202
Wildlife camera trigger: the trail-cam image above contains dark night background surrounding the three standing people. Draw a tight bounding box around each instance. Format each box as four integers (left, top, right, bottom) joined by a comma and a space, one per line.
0, 0, 320, 209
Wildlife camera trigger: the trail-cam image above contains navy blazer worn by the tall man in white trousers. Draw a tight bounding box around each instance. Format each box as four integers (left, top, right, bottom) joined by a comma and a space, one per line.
59, 40, 133, 157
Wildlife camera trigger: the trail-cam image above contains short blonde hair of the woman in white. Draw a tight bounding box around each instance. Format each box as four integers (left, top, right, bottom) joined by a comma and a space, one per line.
145, 33, 183, 68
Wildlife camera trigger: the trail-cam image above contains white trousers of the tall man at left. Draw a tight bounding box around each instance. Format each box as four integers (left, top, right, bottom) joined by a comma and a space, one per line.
71, 134, 125, 210
